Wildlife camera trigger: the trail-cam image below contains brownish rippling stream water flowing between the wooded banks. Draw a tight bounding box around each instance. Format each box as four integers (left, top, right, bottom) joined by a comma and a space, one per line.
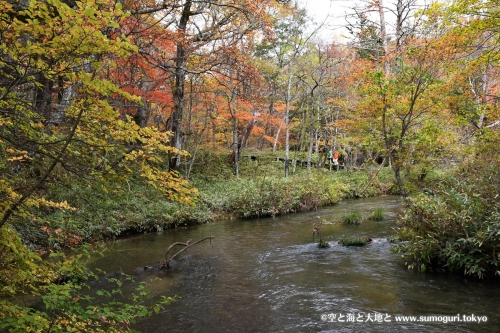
89, 197, 500, 333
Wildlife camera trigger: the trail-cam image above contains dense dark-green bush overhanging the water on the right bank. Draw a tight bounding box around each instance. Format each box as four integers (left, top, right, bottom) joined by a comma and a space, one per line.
395, 147, 500, 278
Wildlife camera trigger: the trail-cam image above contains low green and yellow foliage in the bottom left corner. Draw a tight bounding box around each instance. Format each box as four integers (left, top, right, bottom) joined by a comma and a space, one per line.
0, 226, 174, 333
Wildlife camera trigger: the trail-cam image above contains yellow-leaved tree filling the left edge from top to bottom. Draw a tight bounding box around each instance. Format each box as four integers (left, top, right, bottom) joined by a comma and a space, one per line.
0, 0, 192, 332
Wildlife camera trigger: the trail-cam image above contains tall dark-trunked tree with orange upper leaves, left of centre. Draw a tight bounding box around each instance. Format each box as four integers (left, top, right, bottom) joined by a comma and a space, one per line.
121, 0, 286, 170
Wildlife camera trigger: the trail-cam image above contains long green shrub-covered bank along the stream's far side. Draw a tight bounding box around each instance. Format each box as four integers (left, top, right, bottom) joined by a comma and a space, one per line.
14, 151, 397, 248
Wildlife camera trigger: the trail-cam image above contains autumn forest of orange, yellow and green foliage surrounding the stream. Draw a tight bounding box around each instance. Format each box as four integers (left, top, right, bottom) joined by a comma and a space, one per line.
0, 0, 500, 332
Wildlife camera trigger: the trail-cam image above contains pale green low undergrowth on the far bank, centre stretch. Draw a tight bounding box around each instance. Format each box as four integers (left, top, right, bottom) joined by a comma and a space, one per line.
192, 154, 394, 218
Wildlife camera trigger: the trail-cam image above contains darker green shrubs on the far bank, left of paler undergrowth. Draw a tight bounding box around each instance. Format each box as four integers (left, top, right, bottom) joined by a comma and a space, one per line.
12, 179, 213, 246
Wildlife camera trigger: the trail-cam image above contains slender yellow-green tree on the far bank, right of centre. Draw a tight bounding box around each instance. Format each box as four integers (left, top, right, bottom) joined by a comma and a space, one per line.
352, 43, 447, 198
